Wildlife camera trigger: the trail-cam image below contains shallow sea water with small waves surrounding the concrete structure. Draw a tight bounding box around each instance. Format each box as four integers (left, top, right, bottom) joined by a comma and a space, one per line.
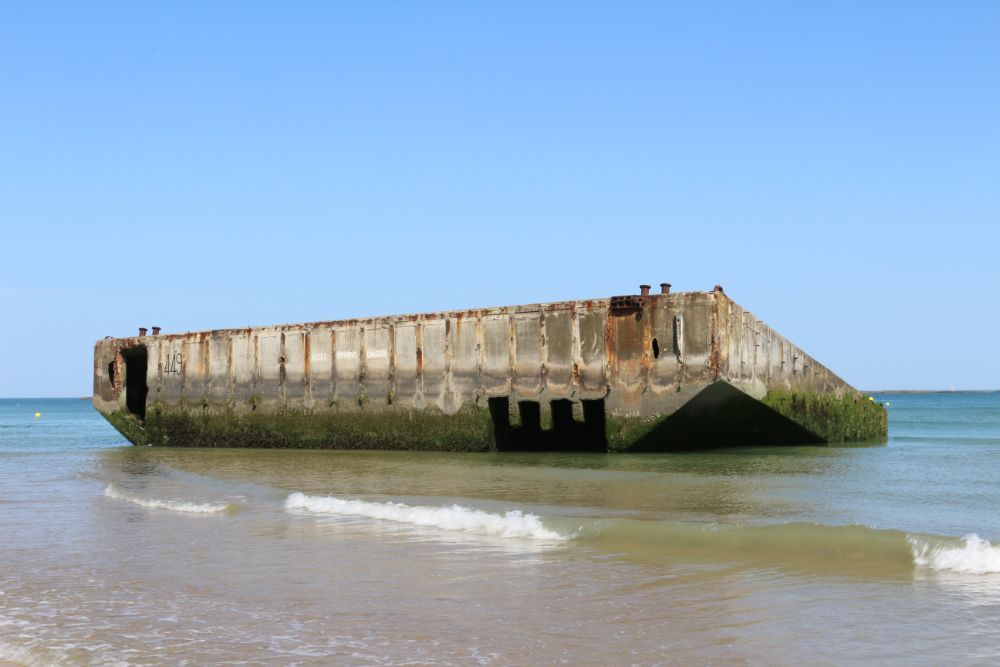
0, 392, 1000, 665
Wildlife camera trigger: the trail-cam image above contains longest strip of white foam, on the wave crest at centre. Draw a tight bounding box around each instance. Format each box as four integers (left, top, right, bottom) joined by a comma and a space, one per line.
285, 493, 567, 540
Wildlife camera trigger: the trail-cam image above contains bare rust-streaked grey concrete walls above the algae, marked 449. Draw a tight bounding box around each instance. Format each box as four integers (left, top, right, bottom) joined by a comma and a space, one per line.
94, 290, 876, 452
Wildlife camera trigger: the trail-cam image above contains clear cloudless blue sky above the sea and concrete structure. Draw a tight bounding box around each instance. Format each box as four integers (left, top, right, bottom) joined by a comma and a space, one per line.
0, 0, 1000, 397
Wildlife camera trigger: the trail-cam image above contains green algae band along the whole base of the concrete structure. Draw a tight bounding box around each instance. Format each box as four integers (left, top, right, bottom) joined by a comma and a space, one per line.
108, 391, 887, 452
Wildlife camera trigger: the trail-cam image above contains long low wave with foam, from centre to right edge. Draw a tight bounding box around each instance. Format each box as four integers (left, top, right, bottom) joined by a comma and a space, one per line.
276, 492, 1000, 575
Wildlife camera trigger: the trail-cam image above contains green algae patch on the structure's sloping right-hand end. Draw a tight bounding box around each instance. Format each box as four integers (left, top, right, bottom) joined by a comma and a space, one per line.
761, 391, 889, 442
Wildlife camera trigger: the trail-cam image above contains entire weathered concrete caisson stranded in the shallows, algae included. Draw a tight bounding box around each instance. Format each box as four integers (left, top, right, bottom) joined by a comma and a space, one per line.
94, 288, 886, 451
